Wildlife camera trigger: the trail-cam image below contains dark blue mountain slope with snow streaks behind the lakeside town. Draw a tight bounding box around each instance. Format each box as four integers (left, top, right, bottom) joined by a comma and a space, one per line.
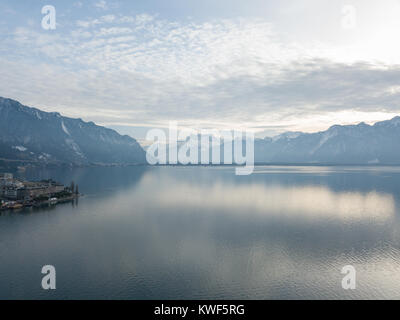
0, 97, 146, 165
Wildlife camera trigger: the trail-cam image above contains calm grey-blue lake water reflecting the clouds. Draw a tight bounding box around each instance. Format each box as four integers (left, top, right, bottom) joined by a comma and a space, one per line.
0, 167, 400, 299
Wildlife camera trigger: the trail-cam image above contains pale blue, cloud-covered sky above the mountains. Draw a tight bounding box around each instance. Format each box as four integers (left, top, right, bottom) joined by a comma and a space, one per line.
0, 0, 400, 139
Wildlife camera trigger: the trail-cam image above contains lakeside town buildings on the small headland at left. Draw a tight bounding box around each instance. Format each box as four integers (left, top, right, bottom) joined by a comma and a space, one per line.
0, 173, 79, 211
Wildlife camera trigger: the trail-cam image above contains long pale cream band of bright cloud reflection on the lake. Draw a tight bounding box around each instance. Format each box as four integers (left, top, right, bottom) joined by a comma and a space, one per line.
152, 183, 395, 220
